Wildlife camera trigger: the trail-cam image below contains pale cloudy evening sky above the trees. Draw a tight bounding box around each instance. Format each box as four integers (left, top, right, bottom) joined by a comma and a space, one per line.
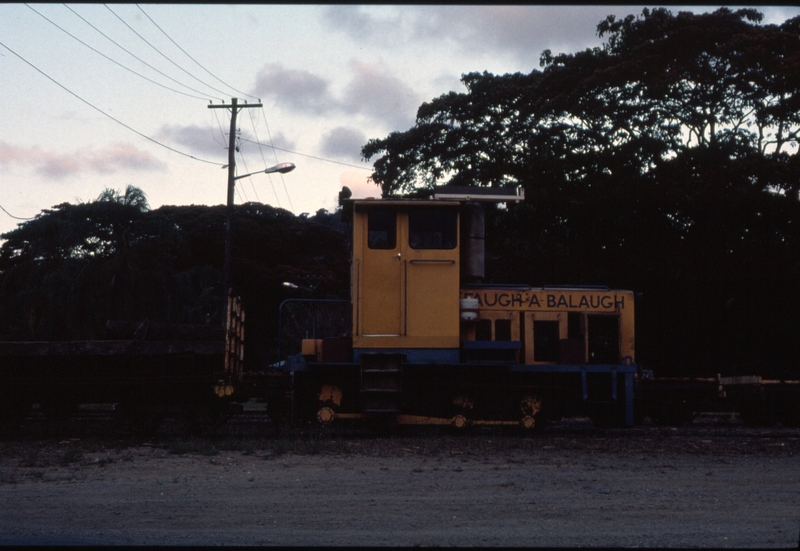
0, 3, 800, 237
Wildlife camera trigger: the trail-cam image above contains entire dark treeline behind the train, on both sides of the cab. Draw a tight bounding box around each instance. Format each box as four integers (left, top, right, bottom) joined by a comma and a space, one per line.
0, 9, 800, 379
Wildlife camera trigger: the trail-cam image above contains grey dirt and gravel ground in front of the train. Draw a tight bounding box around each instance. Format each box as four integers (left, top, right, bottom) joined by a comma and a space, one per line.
0, 423, 800, 548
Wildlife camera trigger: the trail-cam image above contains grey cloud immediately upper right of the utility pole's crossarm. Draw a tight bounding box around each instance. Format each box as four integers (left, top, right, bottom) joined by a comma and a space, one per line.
255, 63, 336, 114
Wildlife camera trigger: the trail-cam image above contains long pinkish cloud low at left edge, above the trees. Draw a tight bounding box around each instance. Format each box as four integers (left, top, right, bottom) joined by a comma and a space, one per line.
0, 142, 165, 179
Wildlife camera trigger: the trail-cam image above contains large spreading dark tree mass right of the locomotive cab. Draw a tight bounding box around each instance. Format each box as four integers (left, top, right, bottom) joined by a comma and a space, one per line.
362, 9, 800, 379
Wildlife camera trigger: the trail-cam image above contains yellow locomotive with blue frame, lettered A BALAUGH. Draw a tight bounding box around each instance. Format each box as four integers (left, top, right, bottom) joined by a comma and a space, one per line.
288, 187, 637, 429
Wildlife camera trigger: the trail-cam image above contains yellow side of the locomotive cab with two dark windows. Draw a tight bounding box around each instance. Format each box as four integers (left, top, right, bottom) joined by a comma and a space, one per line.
353, 203, 459, 348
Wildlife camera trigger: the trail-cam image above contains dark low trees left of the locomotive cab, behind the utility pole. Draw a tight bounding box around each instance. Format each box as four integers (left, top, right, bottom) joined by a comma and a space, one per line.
0, 186, 349, 366
